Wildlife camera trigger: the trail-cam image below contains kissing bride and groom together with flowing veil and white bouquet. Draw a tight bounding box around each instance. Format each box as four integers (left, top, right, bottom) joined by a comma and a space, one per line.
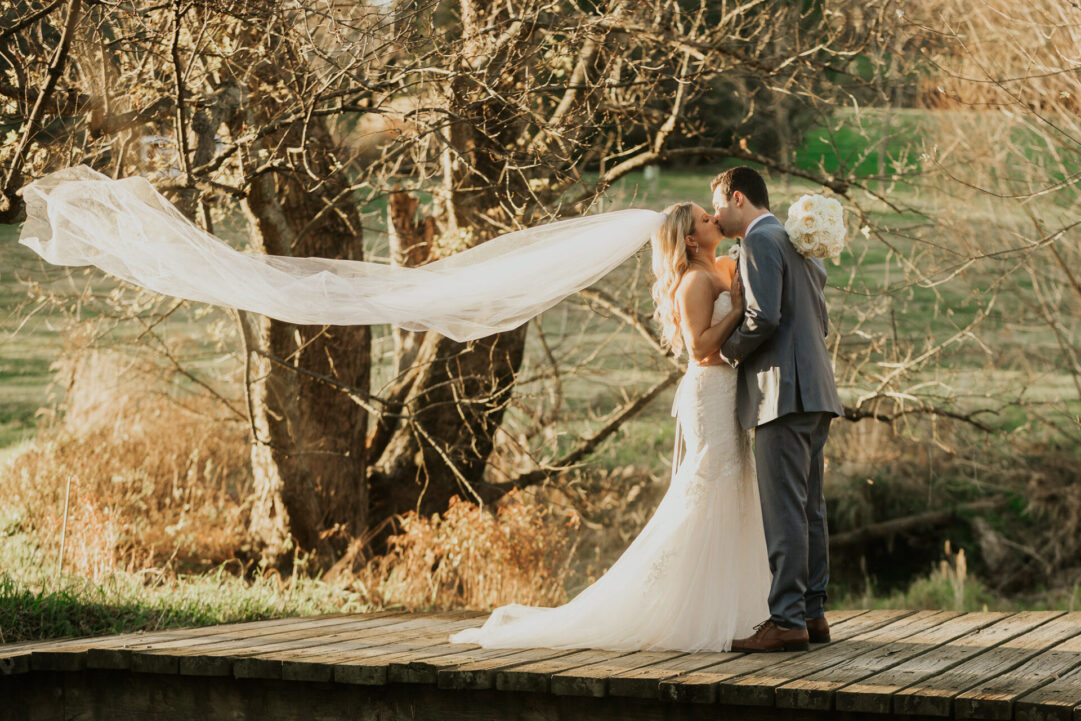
19, 166, 844, 652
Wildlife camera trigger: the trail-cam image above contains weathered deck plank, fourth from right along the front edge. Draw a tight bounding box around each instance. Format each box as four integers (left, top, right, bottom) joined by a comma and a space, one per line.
833, 612, 1062, 713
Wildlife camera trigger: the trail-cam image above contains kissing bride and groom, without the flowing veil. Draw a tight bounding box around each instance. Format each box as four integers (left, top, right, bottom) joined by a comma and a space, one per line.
451, 166, 843, 652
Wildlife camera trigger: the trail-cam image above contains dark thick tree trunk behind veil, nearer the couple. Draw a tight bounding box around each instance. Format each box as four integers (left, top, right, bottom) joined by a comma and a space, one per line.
368, 175, 526, 553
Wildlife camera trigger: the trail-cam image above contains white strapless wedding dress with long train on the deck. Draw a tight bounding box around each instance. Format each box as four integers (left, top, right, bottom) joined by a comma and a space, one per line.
450, 293, 771, 652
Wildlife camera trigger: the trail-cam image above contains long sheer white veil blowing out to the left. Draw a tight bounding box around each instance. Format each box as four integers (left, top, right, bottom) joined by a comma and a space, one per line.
19, 165, 664, 341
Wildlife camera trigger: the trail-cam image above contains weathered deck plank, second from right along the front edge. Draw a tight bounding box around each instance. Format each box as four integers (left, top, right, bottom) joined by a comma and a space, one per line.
953, 636, 1081, 720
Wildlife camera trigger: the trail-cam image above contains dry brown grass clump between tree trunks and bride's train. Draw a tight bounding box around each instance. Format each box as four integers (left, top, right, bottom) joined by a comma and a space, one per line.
345, 493, 577, 611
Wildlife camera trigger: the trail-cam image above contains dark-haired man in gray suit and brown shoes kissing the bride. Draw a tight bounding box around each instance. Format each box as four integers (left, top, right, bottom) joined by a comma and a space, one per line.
711, 166, 843, 651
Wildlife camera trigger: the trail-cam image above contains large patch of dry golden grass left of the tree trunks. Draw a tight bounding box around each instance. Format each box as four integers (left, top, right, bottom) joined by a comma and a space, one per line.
0, 343, 251, 580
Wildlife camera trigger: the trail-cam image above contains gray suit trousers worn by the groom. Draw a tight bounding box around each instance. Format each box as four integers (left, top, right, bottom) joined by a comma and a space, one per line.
755, 412, 832, 628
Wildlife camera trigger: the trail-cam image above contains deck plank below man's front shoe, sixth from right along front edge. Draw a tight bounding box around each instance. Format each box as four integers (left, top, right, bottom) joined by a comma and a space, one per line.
717, 611, 942, 706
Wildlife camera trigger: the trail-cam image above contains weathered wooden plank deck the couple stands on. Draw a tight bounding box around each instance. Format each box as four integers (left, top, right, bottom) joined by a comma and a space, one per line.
0, 611, 1081, 721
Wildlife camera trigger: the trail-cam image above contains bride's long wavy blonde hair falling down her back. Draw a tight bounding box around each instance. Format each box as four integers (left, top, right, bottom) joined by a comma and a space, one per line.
650, 203, 694, 356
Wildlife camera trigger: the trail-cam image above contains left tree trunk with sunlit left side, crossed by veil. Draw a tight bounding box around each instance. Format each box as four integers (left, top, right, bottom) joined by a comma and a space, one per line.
234, 46, 371, 569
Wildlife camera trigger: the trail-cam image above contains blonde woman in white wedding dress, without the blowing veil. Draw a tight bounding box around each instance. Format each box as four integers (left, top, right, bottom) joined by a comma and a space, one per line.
450, 202, 770, 652
